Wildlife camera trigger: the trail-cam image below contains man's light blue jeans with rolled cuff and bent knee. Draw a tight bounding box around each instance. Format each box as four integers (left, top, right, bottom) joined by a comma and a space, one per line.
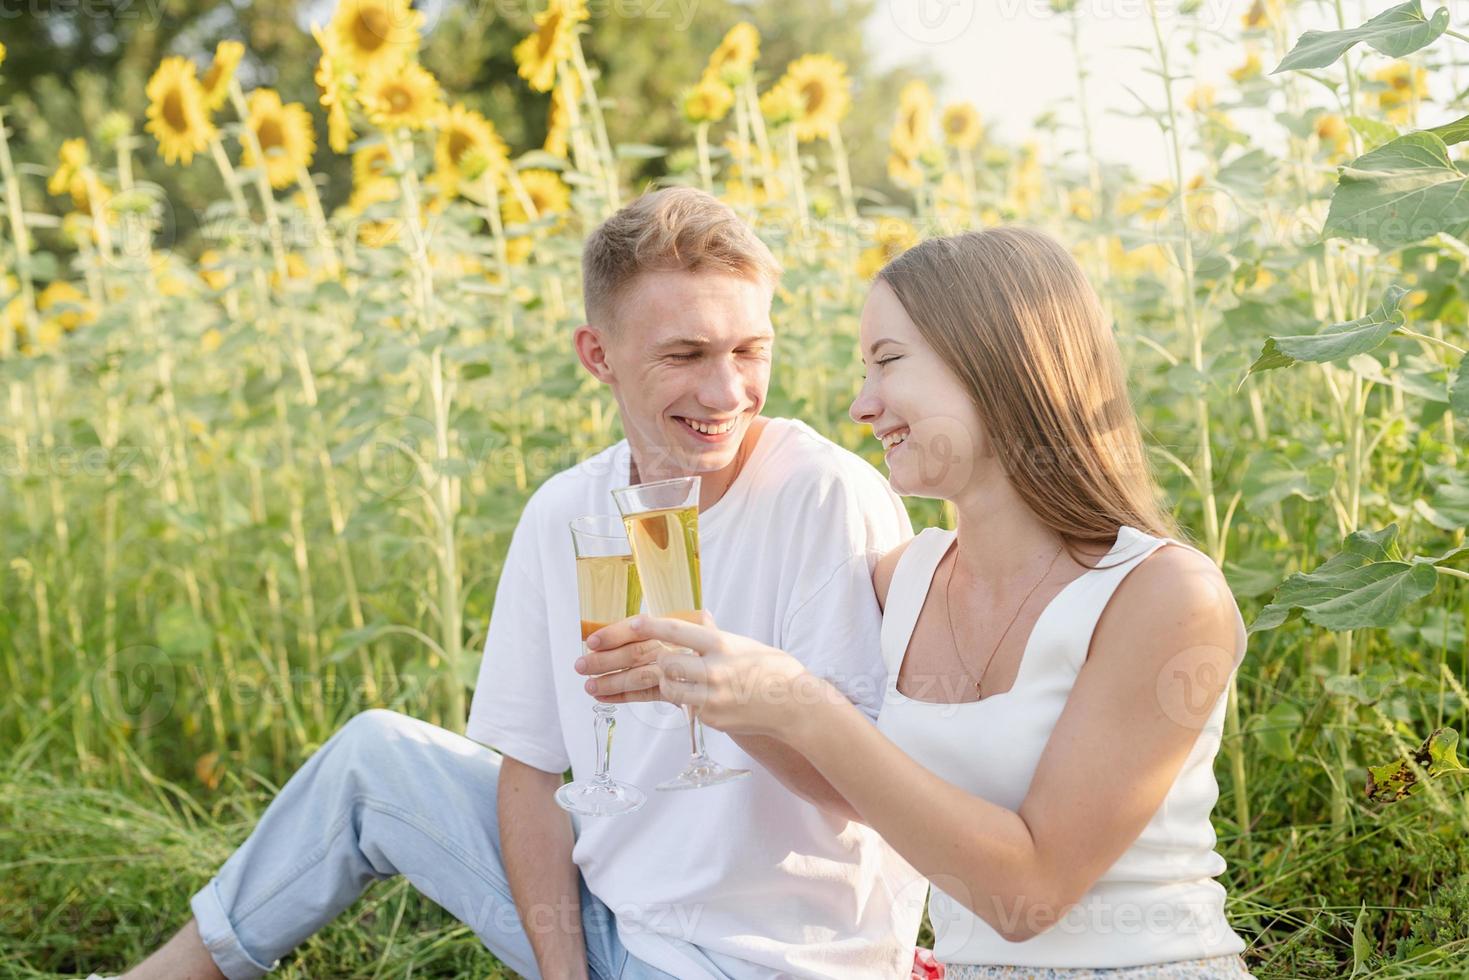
190, 708, 724, 980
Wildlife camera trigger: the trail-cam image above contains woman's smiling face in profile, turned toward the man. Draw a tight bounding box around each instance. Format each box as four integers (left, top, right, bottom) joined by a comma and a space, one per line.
851, 279, 992, 500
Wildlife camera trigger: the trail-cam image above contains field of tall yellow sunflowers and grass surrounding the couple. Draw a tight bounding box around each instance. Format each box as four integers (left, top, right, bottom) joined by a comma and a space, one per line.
0, 0, 1469, 977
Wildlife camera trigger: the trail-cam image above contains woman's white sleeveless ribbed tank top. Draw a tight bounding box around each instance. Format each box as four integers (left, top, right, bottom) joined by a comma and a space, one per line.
877, 526, 1246, 967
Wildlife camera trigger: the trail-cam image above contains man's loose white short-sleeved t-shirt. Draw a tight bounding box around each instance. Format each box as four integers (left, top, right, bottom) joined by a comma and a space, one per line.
467, 419, 927, 980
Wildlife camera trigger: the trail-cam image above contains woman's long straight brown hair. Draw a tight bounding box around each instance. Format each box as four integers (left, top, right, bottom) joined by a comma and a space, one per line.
878, 226, 1180, 555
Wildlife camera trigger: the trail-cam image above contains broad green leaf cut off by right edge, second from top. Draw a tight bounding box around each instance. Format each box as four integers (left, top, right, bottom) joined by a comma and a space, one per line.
1322, 132, 1469, 248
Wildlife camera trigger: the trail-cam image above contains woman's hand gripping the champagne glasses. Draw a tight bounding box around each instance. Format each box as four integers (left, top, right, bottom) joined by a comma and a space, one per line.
576, 611, 845, 738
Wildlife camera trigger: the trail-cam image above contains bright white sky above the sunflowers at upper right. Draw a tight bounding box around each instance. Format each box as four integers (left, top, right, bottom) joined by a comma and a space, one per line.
868, 0, 1469, 179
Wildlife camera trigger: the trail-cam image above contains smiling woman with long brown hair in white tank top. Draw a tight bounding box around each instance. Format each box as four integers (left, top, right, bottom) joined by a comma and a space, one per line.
586, 228, 1250, 980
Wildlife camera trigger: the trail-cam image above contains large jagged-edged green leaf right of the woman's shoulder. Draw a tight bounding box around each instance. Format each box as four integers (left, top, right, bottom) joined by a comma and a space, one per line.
1250, 525, 1453, 633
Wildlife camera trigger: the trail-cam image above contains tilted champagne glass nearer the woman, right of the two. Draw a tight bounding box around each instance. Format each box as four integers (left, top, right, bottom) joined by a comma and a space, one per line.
613, 476, 749, 789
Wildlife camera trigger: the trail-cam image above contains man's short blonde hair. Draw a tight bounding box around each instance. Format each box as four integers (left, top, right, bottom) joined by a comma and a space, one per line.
582, 187, 782, 326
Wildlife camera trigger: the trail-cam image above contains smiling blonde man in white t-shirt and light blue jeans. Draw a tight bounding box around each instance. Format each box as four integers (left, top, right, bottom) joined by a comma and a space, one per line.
117, 188, 927, 980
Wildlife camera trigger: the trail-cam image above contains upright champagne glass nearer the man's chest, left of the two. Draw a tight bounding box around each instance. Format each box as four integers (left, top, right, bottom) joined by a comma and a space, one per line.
555, 514, 648, 817
